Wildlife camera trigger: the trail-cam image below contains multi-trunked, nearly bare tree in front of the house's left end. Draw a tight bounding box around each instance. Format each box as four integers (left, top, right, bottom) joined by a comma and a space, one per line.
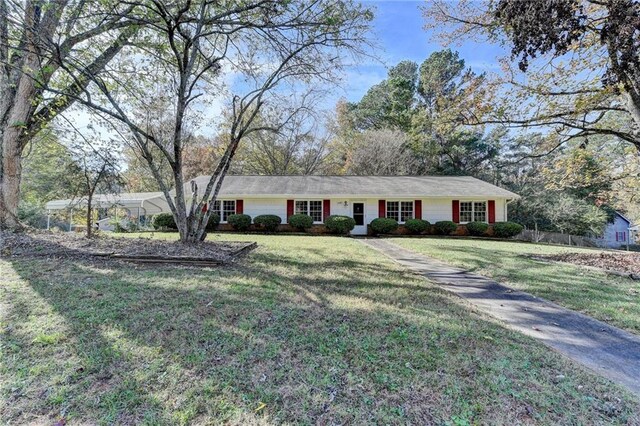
77, 0, 372, 242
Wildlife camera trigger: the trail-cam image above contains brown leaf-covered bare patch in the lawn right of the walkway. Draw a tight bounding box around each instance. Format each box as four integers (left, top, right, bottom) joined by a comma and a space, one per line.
536, 252, 640, 278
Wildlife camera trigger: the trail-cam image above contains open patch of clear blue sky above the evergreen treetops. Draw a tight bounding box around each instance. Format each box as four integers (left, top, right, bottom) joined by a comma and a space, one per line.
338, 0, 504, 104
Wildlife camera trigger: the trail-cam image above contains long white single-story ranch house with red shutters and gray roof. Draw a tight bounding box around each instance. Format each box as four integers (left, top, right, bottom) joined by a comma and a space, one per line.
47, 176, 519, 235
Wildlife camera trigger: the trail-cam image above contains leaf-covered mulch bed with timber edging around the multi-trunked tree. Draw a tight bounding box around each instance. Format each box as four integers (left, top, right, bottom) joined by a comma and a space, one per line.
0, 231, 255, 264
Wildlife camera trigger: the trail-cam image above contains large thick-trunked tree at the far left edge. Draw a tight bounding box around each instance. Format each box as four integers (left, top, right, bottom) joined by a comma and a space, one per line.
0, 0, 141, 229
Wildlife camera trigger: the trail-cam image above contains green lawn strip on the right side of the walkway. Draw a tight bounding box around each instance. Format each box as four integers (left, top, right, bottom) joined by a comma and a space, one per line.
392, 238, 640, 333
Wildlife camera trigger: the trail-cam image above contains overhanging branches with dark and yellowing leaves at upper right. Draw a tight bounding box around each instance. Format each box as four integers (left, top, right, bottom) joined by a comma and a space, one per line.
423, 0, 640, 152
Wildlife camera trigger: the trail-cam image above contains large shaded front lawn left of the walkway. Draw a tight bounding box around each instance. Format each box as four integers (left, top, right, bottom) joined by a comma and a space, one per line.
0, 235, 640, 425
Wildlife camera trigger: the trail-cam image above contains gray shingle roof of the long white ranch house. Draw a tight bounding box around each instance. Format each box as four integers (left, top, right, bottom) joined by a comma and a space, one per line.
185, 176, 519, 198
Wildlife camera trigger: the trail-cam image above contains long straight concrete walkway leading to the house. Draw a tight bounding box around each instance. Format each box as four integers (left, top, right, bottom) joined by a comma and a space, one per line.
360, 239, 640, 395
